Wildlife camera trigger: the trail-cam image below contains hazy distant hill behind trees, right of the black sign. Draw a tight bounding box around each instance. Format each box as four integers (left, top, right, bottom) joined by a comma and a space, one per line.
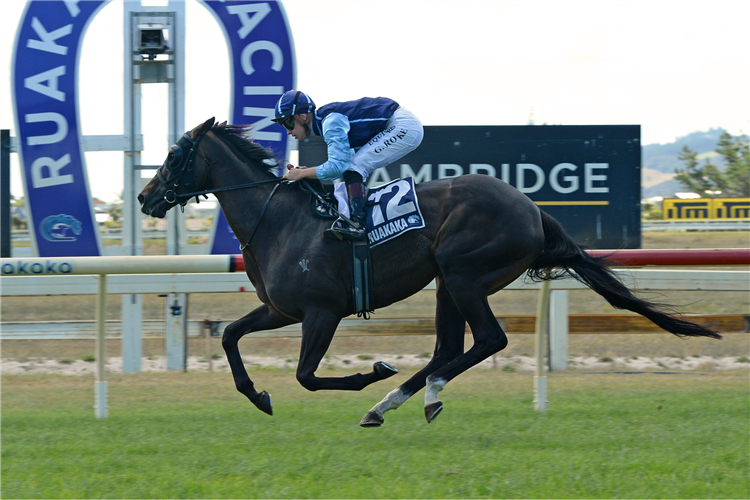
641, 128, 725, 198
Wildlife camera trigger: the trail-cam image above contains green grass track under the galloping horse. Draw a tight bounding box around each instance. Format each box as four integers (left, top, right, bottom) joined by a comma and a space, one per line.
0, 370, 750, 498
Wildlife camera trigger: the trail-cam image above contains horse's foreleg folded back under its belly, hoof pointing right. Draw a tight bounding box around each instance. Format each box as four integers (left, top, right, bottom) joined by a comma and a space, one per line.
297, 309, 398, 391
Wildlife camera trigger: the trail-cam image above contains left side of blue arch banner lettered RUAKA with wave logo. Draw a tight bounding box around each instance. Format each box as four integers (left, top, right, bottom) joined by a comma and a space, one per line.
11, 0, 108, 257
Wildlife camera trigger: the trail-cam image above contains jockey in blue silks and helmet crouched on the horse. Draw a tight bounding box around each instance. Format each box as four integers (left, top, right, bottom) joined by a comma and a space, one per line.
273, 90, 424, 241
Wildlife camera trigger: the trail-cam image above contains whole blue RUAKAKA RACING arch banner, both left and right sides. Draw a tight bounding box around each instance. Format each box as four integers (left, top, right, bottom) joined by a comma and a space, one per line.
11, 0, 296, 257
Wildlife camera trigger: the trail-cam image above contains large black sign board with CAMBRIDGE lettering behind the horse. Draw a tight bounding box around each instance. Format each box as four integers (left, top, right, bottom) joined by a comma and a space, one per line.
299, 125, 641, 249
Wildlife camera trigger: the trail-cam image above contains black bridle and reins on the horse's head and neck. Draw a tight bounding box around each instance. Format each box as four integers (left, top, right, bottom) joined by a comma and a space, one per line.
156, 132, 284, 251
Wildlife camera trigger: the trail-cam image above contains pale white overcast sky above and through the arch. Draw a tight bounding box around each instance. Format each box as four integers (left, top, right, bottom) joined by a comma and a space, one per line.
0, 0, 750, 201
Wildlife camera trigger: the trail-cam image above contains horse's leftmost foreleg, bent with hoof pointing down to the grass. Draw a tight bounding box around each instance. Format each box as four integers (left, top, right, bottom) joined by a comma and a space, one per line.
221, 304, 294, 415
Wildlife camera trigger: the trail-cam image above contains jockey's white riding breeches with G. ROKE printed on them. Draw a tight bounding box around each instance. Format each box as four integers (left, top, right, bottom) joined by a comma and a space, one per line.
349, 108, 424, 180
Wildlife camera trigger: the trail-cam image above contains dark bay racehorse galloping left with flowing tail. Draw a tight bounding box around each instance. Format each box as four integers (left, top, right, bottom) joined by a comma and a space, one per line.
138, 118, 721, 426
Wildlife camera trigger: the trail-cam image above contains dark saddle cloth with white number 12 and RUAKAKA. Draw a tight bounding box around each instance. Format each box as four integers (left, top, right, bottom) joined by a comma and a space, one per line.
334, 177, 425, 247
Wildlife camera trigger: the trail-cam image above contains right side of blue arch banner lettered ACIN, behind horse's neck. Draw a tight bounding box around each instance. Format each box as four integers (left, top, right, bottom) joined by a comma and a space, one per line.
201, 0, 296, 254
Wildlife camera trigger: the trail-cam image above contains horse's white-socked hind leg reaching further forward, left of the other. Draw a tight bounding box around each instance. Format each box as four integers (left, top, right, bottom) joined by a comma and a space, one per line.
359, 276, 466, 427
